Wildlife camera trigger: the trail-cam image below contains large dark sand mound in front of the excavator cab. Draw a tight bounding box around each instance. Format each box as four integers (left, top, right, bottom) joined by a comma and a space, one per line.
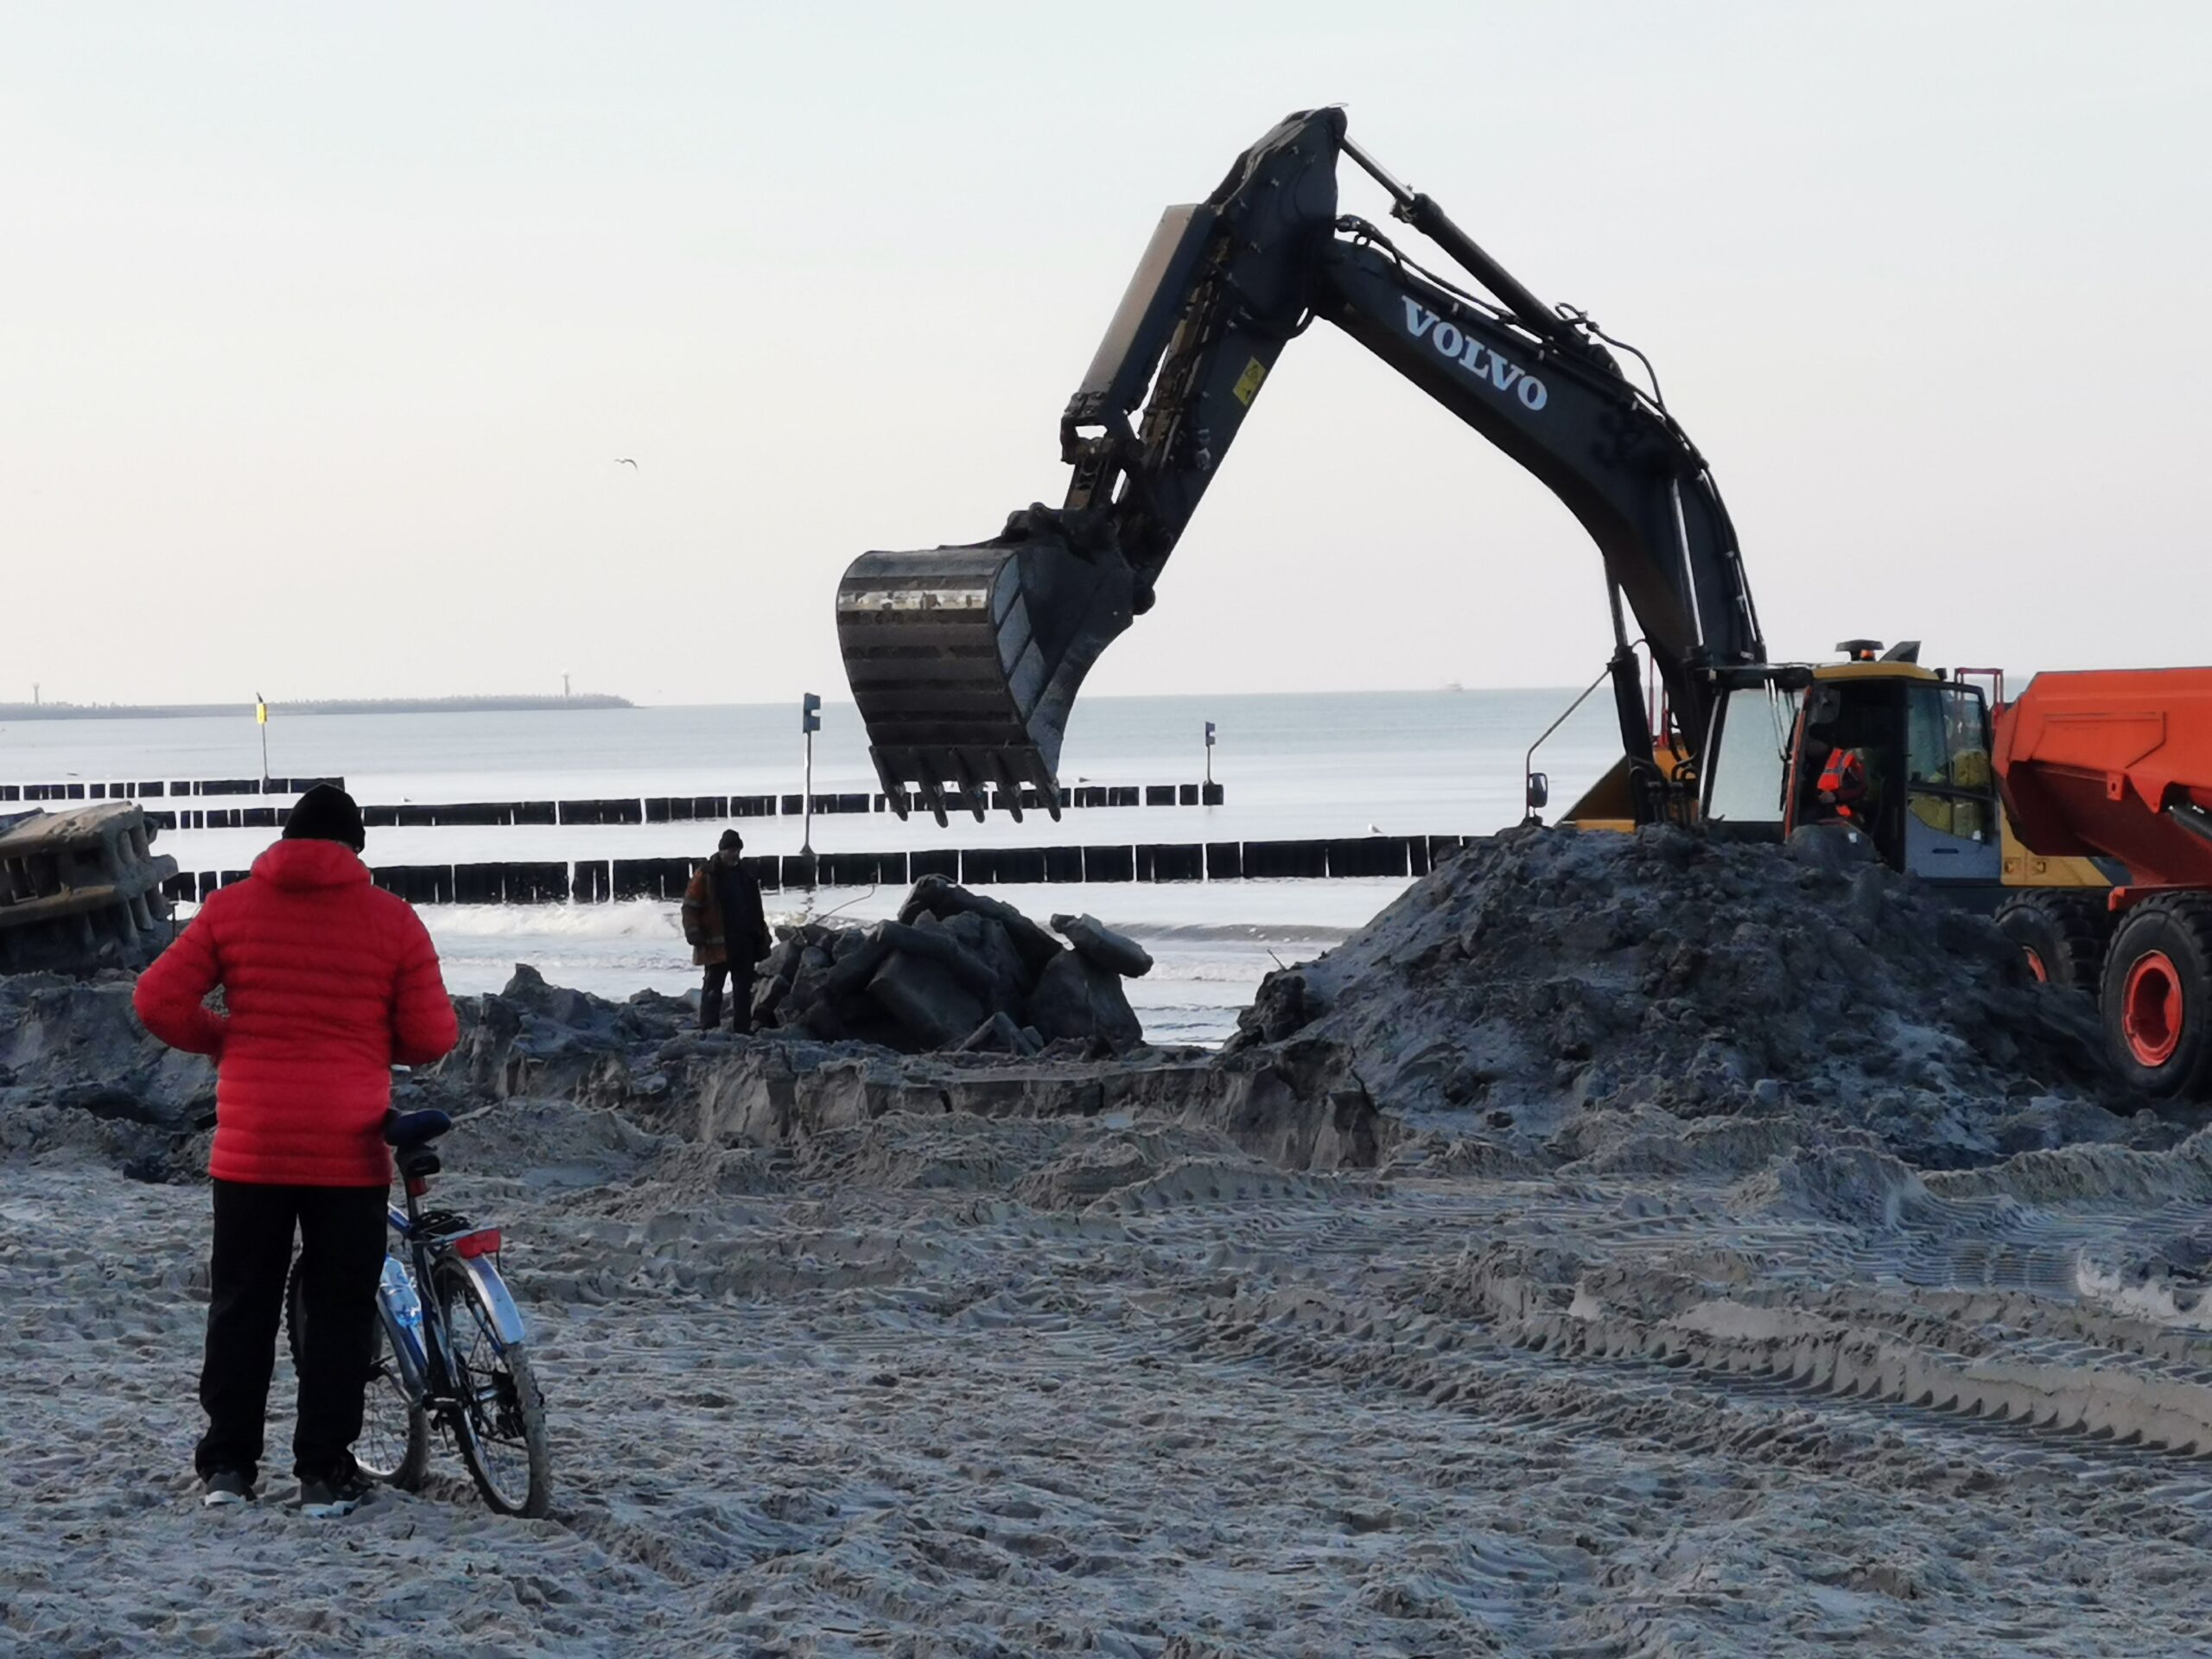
1232, 827, 2172, 1170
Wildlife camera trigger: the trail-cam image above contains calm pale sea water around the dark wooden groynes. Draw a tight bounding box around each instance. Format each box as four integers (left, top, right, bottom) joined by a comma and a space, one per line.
0, 688, 1619, 1044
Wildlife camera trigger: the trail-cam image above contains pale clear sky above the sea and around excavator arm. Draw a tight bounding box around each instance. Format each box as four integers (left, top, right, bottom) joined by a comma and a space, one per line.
0, 0, 2212, 703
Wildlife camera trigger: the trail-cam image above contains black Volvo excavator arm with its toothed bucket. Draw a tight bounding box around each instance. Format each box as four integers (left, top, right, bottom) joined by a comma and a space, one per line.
838, 108, 1765, 821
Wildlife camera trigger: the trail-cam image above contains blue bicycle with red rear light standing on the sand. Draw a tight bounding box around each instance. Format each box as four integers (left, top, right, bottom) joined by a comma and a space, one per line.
285, 1110, 553, 1520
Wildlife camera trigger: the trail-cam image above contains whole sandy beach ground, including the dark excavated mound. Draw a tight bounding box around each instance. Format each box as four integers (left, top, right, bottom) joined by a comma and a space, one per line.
13, 836, 2212, 1659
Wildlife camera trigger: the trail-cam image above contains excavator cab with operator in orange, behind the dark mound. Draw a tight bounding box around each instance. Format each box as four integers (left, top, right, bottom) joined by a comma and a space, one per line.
1770, 639, 2004, 900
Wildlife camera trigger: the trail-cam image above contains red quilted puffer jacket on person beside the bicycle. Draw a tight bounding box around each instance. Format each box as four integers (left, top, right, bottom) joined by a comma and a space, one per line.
133, 841, 458, 1185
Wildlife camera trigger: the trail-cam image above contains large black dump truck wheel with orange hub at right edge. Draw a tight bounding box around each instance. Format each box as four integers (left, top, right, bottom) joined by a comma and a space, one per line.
2104, 893, 2212, 1099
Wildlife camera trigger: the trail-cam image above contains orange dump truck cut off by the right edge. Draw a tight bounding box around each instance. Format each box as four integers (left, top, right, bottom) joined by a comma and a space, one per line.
1995, 668, 2212, 1099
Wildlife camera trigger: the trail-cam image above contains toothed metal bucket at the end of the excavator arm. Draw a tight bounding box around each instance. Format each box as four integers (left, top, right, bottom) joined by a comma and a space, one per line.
836, 536, 1135, 823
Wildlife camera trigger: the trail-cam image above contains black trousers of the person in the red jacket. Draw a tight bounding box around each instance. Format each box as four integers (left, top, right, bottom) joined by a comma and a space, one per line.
193, 1181, 387, 1480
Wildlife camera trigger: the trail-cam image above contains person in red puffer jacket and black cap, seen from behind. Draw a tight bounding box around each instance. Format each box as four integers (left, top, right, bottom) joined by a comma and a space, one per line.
133, 785, 458, 1516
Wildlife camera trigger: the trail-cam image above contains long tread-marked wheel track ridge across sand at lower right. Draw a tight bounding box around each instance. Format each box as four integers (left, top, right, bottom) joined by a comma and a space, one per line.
1194, 1203, 2212, 1466
